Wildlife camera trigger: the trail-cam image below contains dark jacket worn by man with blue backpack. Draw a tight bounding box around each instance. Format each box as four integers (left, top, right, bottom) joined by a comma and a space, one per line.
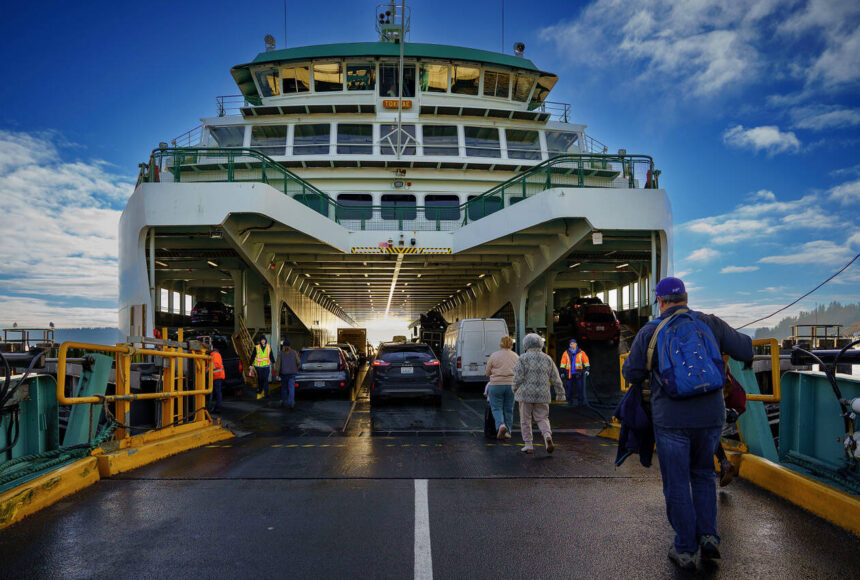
621, 305, 753, 429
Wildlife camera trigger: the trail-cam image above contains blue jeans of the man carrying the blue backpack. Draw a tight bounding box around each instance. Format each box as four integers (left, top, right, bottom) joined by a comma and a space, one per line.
654, 426, 722, 553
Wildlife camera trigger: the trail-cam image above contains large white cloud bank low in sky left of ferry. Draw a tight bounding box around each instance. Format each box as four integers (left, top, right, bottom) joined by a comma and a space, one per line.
0, 131, 133, 326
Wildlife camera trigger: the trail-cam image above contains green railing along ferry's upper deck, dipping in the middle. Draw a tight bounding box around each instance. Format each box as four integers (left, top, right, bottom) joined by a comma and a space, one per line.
138, 147, 659, 231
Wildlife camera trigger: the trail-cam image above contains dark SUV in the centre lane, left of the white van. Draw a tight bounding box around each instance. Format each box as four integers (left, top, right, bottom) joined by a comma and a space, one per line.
370, 342, 442, 405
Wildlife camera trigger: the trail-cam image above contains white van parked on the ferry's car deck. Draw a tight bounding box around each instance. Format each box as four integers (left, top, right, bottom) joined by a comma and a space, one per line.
442, 318, 508, 384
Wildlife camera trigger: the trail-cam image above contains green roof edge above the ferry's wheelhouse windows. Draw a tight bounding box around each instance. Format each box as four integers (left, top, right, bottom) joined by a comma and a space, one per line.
230, 41, 556, 104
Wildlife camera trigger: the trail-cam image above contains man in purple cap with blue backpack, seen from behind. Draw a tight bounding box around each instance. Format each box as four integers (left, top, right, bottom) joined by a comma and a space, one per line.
622, 278, 753, 570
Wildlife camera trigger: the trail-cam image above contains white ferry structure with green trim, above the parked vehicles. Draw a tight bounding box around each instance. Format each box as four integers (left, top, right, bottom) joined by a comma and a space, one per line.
119, 8, 672, 348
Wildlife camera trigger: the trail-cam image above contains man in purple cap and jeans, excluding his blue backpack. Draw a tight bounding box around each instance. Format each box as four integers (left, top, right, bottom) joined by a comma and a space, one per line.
622, 278, 753, 570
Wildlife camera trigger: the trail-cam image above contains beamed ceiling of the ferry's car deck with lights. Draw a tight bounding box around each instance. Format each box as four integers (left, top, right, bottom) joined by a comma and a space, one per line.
151, 221, 651, 323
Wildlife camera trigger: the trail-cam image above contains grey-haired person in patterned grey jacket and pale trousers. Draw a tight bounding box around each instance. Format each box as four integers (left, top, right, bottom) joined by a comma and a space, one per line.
511, 334, 565, 453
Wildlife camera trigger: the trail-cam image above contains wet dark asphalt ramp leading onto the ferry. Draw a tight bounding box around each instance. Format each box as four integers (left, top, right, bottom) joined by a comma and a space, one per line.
0, 364, 860, 578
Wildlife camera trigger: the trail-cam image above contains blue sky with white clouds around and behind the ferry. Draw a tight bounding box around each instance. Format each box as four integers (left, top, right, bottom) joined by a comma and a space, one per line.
0, 0, 860, 326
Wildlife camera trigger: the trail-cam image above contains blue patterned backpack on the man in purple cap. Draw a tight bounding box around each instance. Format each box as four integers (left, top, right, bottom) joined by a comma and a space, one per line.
647, 309, 726, 399
